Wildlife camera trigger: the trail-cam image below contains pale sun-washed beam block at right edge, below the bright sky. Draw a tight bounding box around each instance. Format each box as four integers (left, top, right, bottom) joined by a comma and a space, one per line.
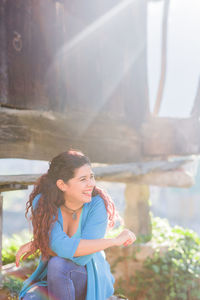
142, 117, 200, 159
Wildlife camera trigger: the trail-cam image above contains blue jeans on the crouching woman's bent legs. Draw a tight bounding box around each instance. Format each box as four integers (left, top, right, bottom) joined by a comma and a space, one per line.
24, 256, 87, 300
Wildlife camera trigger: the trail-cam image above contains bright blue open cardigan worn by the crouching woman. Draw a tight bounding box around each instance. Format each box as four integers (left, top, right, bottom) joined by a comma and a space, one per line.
19, 194, 114, 300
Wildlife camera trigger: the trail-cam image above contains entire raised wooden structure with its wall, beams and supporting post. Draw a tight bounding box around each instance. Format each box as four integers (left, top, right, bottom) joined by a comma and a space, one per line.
0, 0, 200, 288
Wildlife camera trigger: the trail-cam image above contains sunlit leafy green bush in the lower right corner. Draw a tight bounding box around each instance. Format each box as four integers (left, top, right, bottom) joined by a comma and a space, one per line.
112, 218, 200, 300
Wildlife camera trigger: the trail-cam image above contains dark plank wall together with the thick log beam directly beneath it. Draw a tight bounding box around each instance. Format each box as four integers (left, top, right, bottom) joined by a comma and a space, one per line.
0, 0, 149, 163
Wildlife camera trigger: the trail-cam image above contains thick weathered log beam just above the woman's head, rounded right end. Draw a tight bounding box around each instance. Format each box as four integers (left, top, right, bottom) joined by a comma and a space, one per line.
0, 108, 141, 163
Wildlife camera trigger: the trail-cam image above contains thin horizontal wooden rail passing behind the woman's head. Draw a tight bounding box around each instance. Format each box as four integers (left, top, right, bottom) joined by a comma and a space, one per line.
0, 159, 194, 190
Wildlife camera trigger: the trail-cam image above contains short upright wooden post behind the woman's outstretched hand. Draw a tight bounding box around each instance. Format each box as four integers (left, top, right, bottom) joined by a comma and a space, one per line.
124, 183, 151, 236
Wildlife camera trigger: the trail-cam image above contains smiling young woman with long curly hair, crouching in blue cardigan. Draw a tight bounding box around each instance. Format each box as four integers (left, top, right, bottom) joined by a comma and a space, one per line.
16, 150, 136, 300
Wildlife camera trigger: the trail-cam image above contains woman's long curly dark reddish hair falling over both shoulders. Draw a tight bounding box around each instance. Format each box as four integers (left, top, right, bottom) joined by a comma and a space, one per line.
25, 150, 116, 258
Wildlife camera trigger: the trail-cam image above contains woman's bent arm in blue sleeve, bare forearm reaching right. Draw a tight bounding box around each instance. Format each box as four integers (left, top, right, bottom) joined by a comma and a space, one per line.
50, 196, 135, 265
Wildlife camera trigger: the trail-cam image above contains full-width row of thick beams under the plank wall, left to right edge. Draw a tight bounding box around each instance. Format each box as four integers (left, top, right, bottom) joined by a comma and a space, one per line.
0, 108, 200, 164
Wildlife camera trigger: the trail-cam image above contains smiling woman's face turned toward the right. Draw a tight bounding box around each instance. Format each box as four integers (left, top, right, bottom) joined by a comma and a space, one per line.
61, 164, 95, 203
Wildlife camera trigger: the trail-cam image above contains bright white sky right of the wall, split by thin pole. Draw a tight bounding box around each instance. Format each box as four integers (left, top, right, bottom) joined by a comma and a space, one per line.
148, 0, 200, 117
